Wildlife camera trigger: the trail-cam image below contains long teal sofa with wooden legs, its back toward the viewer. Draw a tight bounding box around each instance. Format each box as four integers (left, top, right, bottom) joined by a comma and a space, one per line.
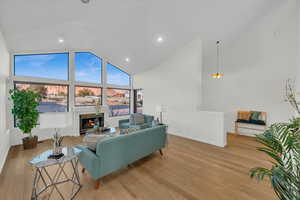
79, 125, 167, 188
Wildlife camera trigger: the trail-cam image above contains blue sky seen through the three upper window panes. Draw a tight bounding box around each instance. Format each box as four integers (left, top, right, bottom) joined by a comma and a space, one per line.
15, 52, 130, 86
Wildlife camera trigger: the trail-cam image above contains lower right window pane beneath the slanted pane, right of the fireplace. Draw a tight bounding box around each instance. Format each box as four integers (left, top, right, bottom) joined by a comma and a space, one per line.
106, 89, 130, 117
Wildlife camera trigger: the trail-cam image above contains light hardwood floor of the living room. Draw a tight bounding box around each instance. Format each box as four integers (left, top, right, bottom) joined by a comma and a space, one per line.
0, 135, 276, 200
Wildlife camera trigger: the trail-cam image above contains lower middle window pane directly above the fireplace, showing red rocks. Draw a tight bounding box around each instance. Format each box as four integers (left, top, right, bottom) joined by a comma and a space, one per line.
75, 86, 102, 106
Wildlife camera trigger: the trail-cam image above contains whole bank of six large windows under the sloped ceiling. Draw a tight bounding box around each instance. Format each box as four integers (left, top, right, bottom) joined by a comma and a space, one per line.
12, 51, 132, 116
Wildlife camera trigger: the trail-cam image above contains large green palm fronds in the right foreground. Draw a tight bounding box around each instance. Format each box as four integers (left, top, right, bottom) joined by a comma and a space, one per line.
250, 118, 300, 200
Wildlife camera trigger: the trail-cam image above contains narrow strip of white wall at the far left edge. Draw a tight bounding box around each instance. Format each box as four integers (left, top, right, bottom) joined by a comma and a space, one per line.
0, 28, 10, 173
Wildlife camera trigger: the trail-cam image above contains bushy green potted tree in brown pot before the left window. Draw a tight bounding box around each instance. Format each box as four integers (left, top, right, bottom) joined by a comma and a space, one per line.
9, 89, 41, 149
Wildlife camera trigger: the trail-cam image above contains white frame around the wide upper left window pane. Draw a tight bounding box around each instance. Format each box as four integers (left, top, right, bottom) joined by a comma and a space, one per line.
12, 51, 70, 81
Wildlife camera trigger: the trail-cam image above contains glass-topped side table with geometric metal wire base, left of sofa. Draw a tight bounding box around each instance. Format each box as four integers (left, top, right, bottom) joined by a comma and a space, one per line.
29, 147, 82, 199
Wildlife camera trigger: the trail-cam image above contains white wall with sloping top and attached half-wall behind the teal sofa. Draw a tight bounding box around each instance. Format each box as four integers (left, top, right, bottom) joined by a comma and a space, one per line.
134, 39, 226, 146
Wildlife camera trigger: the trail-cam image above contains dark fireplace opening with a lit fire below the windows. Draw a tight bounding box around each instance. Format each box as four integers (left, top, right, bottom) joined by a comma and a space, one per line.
79, 113, 104, 134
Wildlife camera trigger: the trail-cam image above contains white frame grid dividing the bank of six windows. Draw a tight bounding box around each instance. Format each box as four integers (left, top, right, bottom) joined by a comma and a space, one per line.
6, 49, 133, 128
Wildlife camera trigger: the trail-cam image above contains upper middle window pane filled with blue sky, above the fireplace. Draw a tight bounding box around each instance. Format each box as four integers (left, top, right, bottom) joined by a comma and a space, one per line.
75, 52, 102, 83
